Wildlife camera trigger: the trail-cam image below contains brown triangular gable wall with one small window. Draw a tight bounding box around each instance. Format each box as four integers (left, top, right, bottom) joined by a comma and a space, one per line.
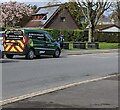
45, 6, 79, 30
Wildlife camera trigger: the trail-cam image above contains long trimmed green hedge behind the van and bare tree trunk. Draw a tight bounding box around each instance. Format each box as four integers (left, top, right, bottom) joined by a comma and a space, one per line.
2, 28, 120, 43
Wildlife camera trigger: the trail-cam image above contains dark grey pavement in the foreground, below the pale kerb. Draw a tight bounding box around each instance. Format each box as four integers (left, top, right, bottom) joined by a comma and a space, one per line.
3, 74, 120, 110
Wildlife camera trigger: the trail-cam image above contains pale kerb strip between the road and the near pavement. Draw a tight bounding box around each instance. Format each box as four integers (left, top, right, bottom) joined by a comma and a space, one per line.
0, 74, 117, 106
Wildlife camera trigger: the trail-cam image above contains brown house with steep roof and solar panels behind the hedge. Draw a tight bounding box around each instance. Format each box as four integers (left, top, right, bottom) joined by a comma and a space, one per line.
25, 4, 79, 30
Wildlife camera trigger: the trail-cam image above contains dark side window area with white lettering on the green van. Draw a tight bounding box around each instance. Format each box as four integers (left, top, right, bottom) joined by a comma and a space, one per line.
28, 32, 46, 41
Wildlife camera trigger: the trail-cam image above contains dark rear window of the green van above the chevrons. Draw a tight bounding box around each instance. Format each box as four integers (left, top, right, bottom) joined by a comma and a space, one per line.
5, 30, 23, 40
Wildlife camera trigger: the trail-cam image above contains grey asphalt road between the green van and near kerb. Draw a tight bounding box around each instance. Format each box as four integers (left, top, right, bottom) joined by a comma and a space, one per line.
2, 53, 118, 99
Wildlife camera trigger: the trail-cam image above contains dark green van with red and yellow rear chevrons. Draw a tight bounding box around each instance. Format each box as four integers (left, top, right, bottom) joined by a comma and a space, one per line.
4, 29, 61, 59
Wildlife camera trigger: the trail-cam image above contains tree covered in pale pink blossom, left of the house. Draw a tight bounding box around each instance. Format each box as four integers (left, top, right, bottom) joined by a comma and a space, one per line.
0, 1, 35, 27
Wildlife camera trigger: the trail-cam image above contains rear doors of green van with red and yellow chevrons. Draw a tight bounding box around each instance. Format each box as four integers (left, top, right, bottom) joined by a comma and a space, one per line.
4, 30, 25, 53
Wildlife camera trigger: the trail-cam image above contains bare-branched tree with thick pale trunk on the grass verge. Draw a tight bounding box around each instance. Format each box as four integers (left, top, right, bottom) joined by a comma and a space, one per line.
77, 0, 111, 42
